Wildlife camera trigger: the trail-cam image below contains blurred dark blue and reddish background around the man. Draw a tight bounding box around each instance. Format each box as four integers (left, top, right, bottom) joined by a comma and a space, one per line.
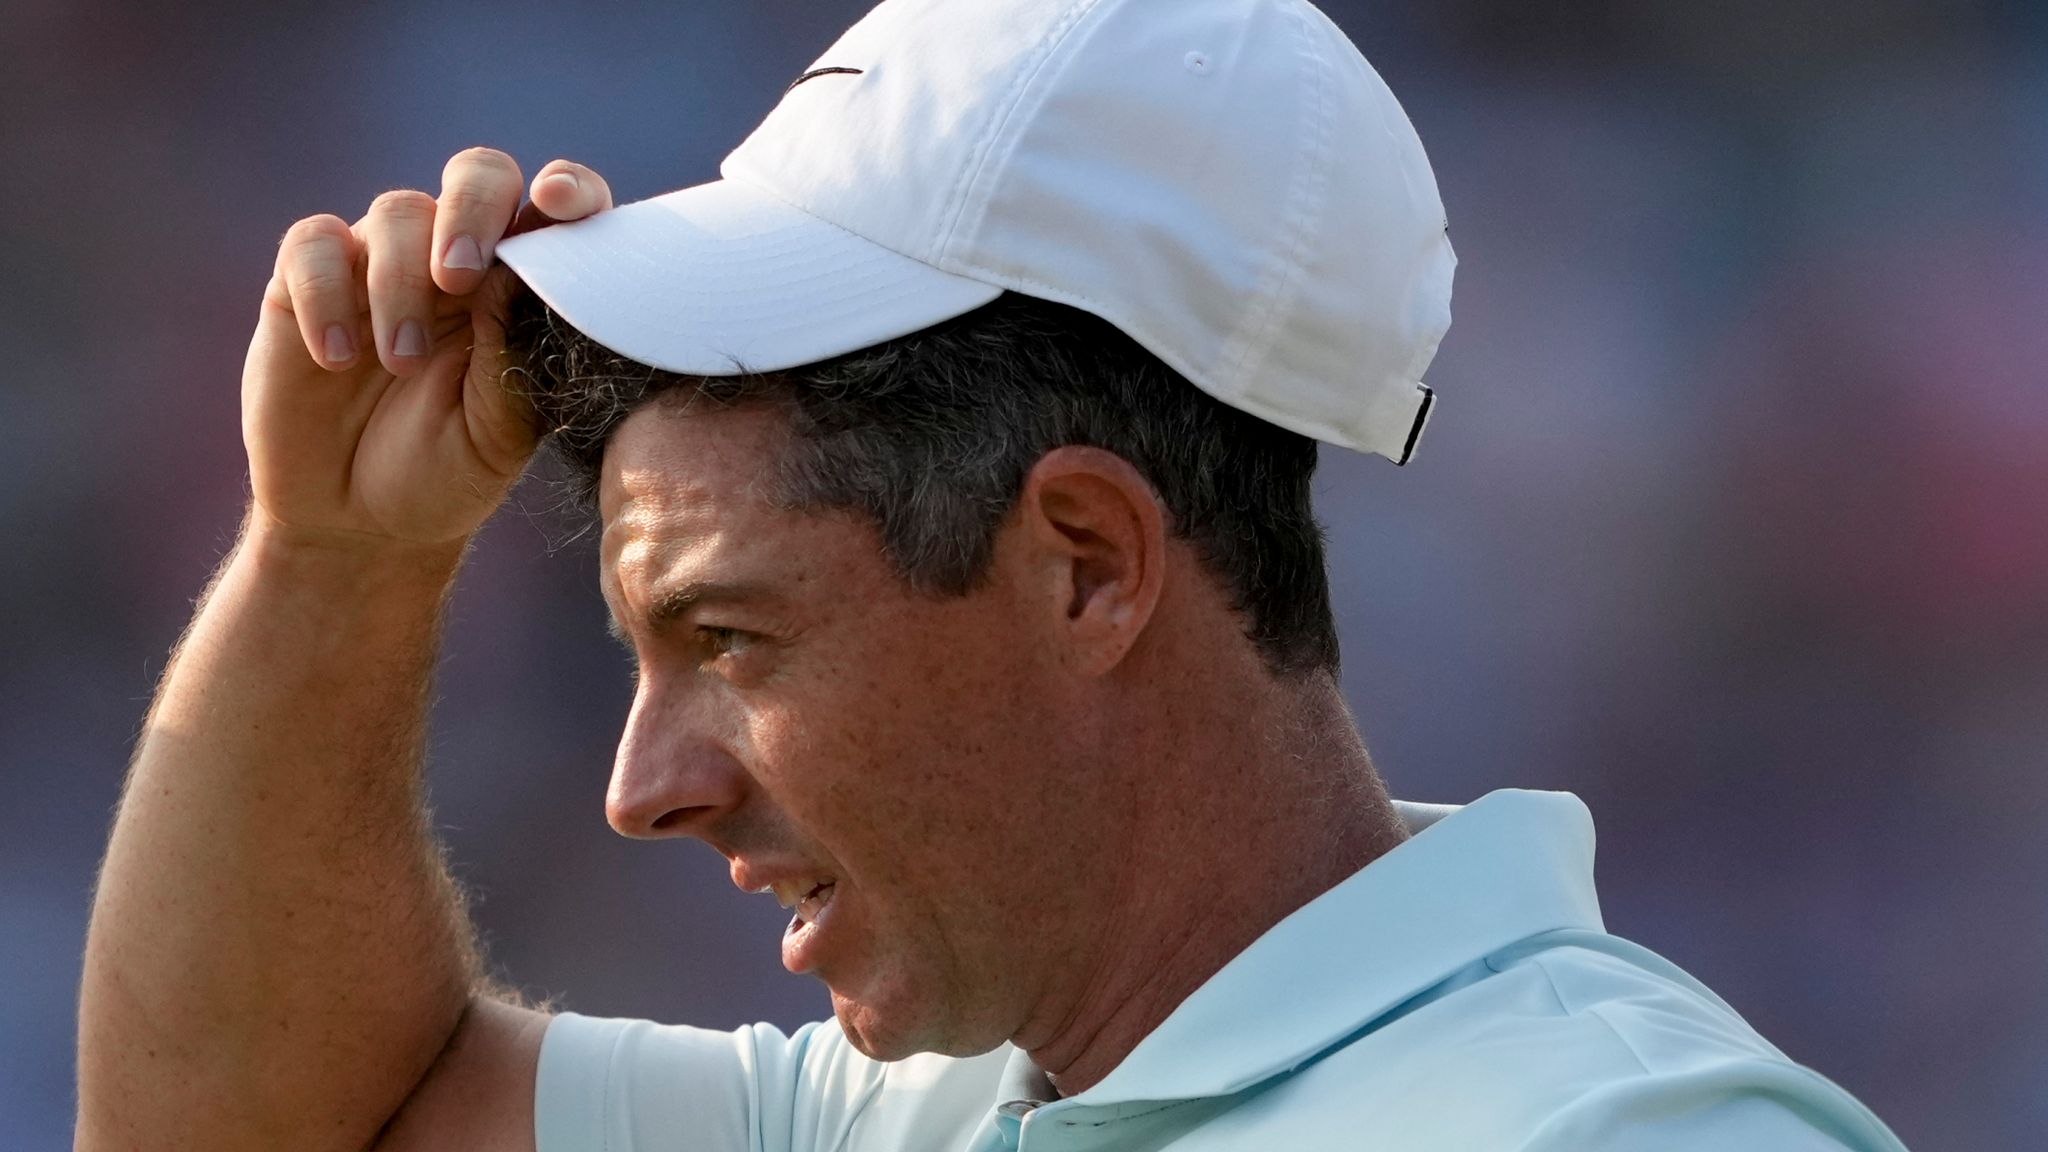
0, 0, 2048, 1150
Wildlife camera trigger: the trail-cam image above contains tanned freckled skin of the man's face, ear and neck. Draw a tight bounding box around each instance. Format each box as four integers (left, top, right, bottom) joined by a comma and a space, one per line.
600, 402, 1401, 1093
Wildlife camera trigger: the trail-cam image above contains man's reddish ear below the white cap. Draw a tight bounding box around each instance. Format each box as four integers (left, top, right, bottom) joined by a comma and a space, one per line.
1018, 445, 1165, 676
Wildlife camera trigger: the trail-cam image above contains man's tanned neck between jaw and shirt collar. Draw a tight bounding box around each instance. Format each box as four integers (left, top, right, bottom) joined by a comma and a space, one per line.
1016, 674, 1405, 1097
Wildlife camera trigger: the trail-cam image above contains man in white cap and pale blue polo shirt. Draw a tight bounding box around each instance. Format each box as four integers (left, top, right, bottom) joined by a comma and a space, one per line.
78, 0, 1896, 1152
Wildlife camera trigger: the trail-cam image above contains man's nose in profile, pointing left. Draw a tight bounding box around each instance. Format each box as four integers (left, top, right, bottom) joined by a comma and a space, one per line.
604, 674, 748, 840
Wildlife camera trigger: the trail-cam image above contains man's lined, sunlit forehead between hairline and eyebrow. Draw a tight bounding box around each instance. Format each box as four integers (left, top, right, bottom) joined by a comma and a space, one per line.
598, 402, 797, 584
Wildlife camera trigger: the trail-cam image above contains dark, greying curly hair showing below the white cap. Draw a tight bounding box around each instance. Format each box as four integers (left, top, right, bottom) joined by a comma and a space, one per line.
506, 287, 1337, 676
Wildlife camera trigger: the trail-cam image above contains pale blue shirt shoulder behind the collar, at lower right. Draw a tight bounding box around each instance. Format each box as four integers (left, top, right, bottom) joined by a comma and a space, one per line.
1220, 931, 1901, 1152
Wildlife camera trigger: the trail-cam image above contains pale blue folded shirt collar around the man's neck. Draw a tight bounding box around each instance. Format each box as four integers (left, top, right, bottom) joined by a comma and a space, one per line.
1064, 789, 1602, 1105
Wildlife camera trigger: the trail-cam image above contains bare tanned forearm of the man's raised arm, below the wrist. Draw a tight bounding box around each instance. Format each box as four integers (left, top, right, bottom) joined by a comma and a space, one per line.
78, 512, 475, 1148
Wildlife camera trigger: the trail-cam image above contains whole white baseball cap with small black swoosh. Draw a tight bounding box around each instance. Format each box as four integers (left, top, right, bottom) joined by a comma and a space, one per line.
498, 0, 1456, 463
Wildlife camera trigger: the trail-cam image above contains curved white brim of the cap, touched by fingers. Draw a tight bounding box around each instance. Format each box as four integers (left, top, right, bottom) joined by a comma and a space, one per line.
498, 180, 1001, 375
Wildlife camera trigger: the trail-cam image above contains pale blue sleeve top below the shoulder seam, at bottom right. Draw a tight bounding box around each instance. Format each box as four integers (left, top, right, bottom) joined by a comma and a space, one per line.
1522, 1060, 1905, 1152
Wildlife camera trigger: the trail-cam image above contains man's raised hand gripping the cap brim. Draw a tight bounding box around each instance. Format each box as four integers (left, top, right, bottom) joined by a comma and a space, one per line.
242, 148, 612, 549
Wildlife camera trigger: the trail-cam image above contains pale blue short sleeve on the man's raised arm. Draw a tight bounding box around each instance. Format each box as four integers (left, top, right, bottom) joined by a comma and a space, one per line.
535, 1013, 883, 1152
